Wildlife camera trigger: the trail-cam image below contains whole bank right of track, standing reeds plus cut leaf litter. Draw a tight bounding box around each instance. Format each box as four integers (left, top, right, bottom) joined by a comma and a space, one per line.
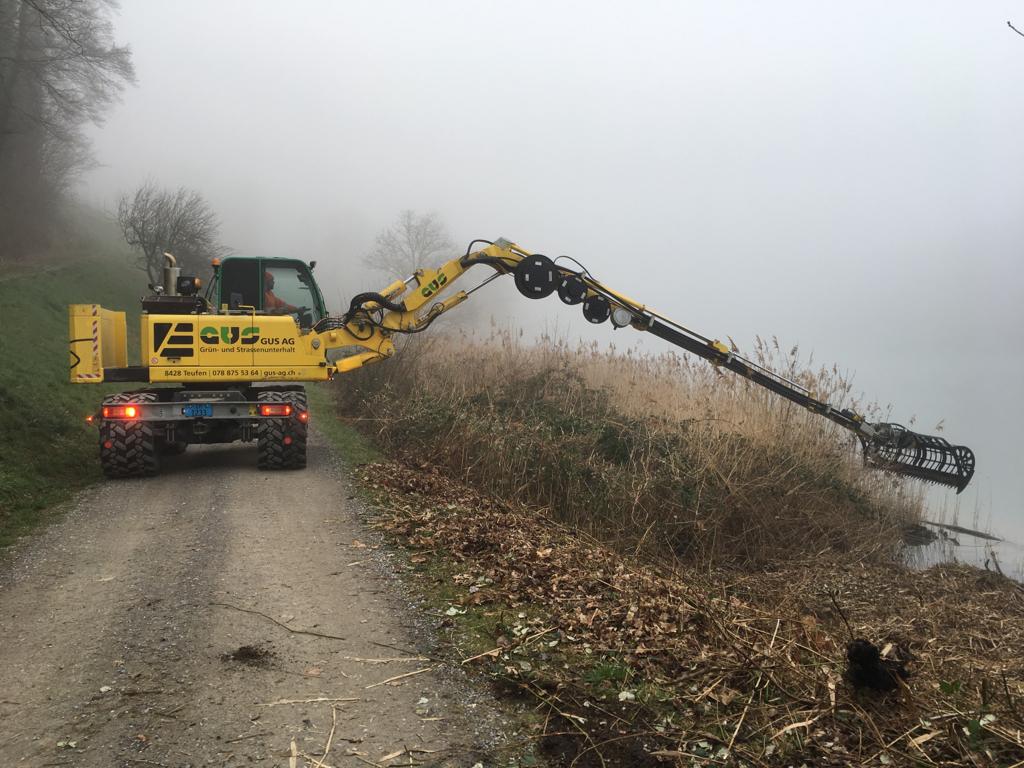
317, 340, 1024, 768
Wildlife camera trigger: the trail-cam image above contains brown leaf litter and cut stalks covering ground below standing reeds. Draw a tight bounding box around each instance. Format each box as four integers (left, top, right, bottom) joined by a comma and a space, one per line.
361, 463, 1024, 767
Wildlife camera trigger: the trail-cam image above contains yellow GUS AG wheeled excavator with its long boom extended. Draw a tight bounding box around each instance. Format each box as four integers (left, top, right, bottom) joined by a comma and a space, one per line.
69, 240, 975, 493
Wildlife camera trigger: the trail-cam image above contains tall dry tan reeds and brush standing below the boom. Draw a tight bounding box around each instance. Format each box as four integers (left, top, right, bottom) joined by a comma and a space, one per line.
338, 333, 922, 565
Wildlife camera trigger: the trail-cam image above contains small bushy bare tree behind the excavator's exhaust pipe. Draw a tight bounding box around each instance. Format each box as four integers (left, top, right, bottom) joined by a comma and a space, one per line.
118, 181, 227, 284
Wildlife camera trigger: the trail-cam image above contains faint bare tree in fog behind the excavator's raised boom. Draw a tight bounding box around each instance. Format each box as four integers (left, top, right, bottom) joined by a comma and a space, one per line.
362, 210, 455, 278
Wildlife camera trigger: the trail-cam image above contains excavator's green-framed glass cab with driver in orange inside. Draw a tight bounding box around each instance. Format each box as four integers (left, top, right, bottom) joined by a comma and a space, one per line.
210, 256, 327, 329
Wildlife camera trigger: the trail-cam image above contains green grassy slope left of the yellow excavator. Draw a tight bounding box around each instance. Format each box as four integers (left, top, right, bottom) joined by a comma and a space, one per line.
0, 223, 145, 547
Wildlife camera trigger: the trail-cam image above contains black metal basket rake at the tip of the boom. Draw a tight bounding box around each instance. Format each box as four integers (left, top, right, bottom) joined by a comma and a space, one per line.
858, 424, 975, 494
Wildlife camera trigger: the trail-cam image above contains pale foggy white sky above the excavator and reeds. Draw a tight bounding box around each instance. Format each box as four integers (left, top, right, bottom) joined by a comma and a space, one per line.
85, 0, 1024, 539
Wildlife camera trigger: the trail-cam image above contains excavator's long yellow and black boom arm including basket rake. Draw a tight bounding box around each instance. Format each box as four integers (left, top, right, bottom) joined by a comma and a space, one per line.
314, 240, 975, 494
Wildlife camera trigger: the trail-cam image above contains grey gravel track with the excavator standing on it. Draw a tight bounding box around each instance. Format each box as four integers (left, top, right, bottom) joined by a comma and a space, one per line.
0, 440, 507, 768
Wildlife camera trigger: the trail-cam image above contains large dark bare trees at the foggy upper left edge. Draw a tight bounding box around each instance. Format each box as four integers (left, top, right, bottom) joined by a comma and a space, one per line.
0, 0, 134, 259
